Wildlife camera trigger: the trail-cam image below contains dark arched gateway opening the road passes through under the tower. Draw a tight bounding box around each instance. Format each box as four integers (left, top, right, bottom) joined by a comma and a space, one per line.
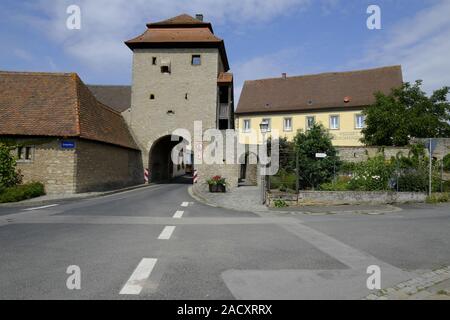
149, 135, 192, 182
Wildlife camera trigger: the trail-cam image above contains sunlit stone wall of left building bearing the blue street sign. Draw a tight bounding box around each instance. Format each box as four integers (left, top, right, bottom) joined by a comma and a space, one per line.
17, 139, 76, 194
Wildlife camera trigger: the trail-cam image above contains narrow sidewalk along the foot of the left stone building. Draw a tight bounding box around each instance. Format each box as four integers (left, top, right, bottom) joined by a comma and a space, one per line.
0, 184, 153, 207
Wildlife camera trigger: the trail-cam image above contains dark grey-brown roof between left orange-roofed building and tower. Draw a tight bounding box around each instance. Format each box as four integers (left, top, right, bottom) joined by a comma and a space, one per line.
87, 85, 131, 112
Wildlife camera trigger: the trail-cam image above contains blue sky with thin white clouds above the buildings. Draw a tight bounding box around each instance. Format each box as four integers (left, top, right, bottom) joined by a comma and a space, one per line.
0, 0, 450, 99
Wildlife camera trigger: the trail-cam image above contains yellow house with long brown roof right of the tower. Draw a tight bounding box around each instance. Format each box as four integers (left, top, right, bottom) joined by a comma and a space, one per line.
235, 66, 403, 147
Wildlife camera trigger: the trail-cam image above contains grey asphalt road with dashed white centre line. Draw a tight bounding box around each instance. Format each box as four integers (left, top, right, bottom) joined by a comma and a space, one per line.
0, 178, 450, 299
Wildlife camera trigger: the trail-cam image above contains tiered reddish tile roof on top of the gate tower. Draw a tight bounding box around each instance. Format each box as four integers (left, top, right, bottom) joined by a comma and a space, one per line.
125, 14, 230, 71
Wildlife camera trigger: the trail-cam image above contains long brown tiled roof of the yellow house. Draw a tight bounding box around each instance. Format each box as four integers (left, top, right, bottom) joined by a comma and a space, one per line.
236, 66, 403, 114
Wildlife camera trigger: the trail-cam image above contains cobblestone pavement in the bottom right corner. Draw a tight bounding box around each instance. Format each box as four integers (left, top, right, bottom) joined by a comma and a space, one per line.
365, 266, 450, 300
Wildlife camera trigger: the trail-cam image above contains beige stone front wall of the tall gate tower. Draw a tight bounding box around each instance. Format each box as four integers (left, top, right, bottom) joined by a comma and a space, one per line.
124, 48, 220, 167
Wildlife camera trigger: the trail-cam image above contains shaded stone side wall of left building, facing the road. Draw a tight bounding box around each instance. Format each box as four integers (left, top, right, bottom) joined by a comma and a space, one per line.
76, 140, 144, 193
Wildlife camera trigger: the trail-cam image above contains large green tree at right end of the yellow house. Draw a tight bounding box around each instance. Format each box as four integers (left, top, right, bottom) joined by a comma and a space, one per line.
361, 80, 450, 146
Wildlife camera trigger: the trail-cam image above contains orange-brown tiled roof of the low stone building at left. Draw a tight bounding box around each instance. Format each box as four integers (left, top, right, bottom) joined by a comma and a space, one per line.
0, 72, 138, 149
